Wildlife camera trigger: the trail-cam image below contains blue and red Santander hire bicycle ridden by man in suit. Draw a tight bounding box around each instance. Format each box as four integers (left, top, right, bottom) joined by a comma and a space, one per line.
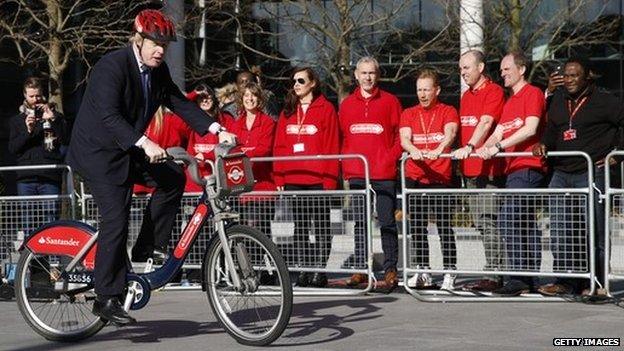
15, 144, 293, 346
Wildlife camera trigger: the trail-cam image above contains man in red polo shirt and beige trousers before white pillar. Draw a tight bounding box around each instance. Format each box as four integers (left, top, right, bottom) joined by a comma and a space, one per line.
453, 50, 505, 291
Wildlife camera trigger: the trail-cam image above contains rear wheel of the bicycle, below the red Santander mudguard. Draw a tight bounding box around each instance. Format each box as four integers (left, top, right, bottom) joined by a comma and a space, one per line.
15, 249, 106, 341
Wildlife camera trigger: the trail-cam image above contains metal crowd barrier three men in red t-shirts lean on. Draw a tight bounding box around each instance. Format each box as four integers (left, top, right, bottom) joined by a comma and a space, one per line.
400, 152, 595, 302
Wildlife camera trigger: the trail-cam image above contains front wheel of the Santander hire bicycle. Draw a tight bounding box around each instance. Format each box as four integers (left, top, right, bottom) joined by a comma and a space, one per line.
204, 225, 293, 346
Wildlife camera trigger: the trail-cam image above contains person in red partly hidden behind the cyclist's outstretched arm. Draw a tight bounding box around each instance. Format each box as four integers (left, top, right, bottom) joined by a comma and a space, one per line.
184, 86, 233, 192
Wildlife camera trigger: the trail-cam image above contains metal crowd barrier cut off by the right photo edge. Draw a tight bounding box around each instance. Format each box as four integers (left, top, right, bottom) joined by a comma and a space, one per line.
603, 151, 624, 295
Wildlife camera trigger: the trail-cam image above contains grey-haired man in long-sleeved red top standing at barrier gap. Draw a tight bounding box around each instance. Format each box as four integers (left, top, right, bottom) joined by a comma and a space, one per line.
338, 57, 402, 291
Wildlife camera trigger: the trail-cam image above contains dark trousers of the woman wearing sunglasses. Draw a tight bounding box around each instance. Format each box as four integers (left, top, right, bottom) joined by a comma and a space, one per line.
284, 184, 332, 267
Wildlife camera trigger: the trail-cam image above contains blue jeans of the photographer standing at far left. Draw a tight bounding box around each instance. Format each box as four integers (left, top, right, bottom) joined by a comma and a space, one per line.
17, 182, 61, 235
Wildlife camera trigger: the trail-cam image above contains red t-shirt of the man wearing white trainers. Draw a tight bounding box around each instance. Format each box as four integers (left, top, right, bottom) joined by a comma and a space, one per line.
400, 102, 459, 184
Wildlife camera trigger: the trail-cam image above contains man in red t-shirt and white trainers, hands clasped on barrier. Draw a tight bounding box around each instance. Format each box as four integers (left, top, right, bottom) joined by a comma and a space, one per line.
399, 69, 459, 290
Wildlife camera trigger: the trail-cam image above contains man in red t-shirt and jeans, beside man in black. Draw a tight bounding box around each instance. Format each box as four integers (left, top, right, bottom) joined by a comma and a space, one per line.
477, 52, 546, 296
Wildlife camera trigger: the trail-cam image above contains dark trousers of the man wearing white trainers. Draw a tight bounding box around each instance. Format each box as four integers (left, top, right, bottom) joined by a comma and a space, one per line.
404, 178, 457, 269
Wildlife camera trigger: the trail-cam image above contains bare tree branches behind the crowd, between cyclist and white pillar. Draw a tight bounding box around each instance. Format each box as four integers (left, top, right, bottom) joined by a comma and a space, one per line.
187, 0, 452, 100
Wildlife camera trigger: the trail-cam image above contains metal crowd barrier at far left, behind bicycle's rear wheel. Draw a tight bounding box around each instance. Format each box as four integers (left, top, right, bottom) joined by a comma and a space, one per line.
0, 165, 76, 278
